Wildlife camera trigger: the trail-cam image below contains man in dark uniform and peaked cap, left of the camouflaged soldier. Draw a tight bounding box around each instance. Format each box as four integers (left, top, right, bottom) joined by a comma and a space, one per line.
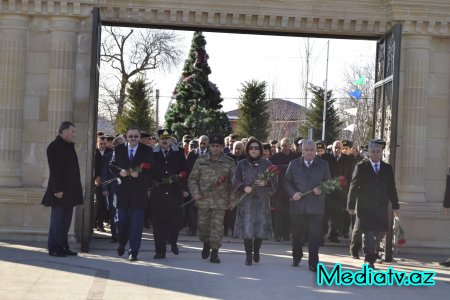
150, 129, 189, 259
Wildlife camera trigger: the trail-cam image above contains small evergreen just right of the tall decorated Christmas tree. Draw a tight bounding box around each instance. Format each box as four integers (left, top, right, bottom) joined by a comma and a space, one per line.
237, 80, 270, 141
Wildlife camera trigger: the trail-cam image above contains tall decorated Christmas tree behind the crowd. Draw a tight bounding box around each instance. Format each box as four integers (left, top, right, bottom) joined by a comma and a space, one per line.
165, 31, 231, 137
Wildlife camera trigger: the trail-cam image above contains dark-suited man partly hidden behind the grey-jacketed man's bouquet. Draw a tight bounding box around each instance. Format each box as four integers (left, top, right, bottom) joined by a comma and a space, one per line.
322, 141, 353, 243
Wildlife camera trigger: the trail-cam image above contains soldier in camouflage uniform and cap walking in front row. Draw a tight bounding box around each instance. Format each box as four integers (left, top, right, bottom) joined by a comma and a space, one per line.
188, 135, 235, 263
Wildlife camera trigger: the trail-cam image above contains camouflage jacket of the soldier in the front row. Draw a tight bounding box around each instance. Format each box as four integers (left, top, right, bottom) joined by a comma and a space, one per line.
188, 154, 236, 209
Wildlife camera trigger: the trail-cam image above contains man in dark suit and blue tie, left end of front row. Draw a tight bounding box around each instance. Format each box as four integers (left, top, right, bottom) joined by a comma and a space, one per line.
110, 127, 154, 261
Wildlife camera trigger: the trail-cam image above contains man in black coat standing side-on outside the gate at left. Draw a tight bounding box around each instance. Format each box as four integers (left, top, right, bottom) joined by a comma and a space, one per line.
42, 121, 83, 257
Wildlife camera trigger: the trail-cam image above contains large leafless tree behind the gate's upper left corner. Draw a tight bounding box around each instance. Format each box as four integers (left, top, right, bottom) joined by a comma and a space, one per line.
99, 26, 182, 123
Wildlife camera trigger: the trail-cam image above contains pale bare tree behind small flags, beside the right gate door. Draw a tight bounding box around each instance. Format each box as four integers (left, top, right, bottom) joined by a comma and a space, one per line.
339, 62, 375, 146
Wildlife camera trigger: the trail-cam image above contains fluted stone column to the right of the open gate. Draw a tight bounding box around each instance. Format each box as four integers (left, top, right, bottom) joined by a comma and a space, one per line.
399, 34, 432, 202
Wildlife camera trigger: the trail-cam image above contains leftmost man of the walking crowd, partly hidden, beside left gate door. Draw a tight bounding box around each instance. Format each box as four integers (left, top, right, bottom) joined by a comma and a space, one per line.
94, 135, 112, 232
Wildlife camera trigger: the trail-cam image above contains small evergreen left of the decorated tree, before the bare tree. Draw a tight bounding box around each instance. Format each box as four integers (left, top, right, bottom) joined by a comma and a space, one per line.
116, 77, 156, 132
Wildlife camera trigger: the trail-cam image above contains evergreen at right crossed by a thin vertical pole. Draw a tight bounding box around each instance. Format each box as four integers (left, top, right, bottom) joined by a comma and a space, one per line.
299, 85, 343, 144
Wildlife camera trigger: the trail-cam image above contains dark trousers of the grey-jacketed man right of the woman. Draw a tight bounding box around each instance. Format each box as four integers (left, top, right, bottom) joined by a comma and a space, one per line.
291, 214, 323, 266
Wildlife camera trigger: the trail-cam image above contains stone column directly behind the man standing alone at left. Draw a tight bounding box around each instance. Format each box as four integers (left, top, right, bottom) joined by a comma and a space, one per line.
43, 17, 79, 187
